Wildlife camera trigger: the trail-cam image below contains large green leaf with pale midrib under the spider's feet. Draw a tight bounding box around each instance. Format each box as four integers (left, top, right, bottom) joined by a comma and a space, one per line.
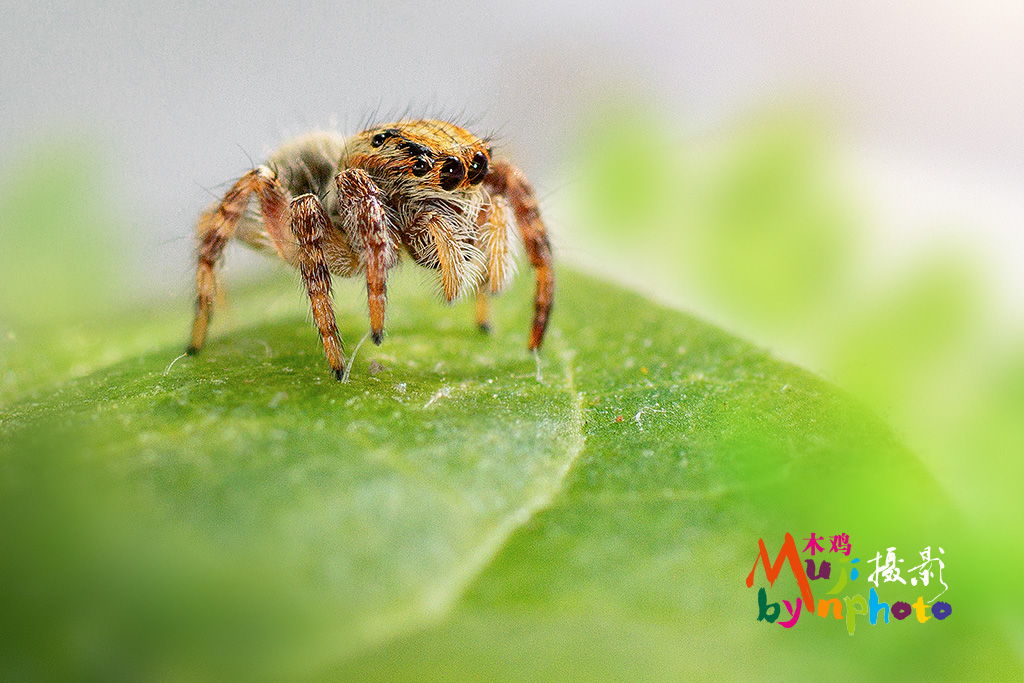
0, 270, 1020, 681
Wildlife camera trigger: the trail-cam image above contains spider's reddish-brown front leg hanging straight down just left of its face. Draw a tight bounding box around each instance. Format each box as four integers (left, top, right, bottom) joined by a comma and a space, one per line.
337, 168, 398, 346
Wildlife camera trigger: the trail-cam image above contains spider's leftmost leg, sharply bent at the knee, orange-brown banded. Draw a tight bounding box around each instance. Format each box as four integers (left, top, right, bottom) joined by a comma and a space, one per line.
186, 166, 288, 355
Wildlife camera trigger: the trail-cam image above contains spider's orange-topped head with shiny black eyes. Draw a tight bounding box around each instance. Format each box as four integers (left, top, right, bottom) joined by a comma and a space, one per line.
343, 120, 490, 200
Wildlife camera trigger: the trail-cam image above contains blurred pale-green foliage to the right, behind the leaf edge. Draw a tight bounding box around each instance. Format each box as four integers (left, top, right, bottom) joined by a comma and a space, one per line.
566, 99, 1024, 532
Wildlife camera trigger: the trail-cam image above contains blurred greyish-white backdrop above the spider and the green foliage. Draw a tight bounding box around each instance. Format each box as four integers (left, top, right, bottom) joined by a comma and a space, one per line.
0, 0, 1024, 307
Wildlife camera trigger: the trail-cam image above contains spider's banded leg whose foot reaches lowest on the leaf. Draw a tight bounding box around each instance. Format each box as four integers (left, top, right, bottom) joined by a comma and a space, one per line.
290, 195, 345, 381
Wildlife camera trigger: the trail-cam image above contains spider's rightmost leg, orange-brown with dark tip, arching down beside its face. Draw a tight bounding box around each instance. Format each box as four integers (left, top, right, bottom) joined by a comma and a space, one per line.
484, 162, 555, 350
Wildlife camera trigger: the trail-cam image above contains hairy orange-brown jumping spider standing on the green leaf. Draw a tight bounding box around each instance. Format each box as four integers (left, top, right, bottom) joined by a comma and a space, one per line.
187, 120, 555, 380
